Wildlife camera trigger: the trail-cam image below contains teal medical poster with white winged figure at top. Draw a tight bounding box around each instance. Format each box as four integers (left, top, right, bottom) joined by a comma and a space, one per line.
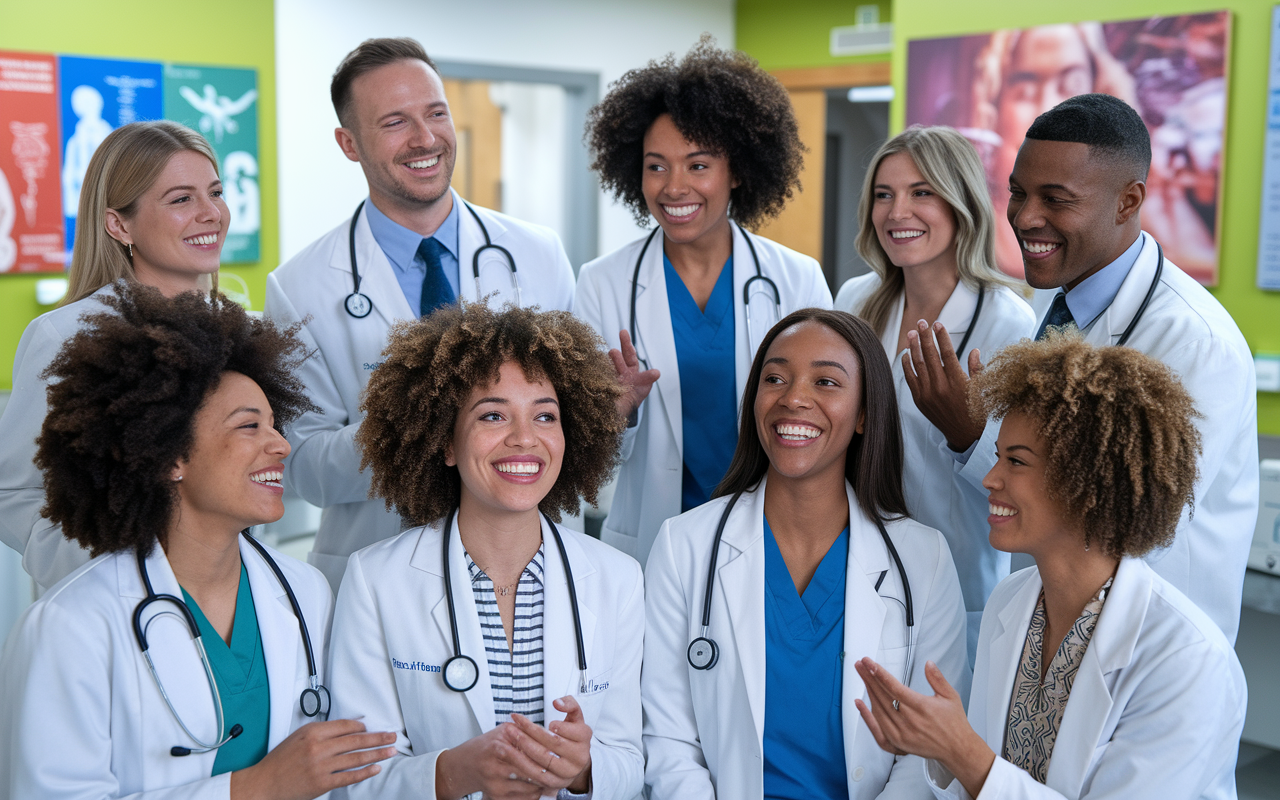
164, 64, 262, 264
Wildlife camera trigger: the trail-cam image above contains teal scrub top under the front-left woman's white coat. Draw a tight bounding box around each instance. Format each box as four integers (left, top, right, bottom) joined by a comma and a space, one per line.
182, 564, 271, 774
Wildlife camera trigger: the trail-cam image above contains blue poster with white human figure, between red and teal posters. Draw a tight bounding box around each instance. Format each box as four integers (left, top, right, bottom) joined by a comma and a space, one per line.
58, 55, 164, 262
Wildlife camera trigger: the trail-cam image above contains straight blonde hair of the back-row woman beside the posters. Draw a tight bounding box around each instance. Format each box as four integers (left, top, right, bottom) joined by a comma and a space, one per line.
63, 119, 218, 306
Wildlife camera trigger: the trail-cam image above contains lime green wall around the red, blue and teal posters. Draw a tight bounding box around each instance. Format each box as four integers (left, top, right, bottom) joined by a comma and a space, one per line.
0, 0, 280, 389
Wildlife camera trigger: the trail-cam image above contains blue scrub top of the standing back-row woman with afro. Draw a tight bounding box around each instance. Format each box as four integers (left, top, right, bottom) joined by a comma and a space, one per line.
662, 253, 737, 511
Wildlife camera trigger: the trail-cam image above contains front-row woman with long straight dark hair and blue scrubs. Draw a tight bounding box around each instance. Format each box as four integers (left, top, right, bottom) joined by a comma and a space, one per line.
640, 308, 969, 800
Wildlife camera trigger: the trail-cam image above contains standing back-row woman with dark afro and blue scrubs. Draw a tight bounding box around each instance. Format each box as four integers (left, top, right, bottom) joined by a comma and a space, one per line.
573, 38, 831, 563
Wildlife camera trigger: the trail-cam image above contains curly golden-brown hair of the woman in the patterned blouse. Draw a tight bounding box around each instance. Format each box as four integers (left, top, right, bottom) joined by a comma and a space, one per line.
969, 333, 1201, 557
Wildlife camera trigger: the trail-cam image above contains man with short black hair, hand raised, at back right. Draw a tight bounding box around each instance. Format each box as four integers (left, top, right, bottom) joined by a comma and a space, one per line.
906, 95, 1258, 643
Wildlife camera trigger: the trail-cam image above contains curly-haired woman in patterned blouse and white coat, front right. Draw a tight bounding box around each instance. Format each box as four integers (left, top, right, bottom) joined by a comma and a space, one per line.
858, 334, 1245, 800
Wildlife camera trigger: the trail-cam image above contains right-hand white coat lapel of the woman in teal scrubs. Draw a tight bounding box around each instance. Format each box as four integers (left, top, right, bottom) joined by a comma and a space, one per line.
239, 536, 306, 748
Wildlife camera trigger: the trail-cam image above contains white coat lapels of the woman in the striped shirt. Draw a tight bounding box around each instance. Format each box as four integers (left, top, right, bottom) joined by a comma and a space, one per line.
410, 516, 596, 731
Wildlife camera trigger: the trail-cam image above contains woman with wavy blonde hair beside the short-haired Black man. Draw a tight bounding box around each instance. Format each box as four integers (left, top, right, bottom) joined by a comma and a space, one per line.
836, 127, 1036, 662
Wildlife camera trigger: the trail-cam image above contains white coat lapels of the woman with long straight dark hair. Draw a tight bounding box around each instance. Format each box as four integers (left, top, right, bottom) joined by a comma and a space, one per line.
716, 479, 890, 753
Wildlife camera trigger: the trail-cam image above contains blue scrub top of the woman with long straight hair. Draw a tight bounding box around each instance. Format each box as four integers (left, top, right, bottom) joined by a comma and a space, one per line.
764, 520, 849, 800
